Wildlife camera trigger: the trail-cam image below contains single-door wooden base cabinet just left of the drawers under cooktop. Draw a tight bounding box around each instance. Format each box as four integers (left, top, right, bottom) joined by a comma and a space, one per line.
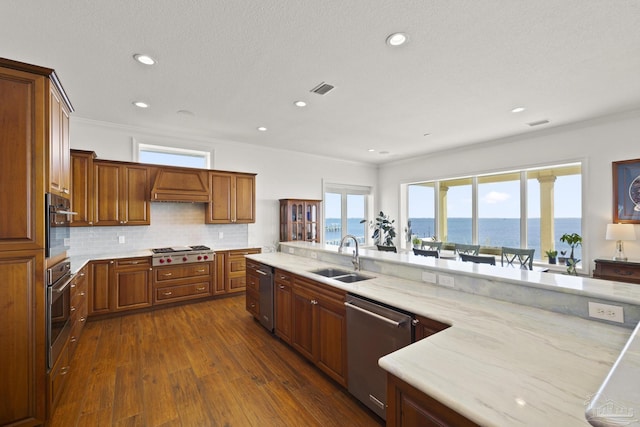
109, 257, 153, 311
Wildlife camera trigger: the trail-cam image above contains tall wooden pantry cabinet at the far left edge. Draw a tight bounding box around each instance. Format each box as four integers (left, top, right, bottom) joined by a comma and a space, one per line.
0, 58, 73, 426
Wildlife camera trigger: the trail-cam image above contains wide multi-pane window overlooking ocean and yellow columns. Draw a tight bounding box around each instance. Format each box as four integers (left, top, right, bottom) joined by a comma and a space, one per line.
407, 163, 582, 259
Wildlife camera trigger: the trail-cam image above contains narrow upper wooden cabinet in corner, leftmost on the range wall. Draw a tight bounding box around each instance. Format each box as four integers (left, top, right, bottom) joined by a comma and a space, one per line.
71, 150, 96, 227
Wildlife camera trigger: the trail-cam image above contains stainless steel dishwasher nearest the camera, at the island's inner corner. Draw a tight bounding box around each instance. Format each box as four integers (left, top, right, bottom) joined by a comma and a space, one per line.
344, 295, 414, 420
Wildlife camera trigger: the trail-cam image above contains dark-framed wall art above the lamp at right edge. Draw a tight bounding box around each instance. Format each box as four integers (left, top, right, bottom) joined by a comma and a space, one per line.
613, 159, 640, 224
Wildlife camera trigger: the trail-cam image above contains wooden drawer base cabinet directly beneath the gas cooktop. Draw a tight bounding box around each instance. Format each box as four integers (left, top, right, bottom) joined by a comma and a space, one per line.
153, 261, 215, 304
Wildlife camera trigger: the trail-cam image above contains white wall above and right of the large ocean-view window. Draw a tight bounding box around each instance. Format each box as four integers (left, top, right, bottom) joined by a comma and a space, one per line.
377, 111, 640, 273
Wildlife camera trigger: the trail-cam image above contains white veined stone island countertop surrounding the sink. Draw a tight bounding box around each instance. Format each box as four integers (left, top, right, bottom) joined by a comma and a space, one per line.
248, 252, 637, 426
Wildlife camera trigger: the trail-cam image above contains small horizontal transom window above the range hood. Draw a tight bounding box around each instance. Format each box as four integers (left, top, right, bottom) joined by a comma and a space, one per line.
134, 140, 212, 169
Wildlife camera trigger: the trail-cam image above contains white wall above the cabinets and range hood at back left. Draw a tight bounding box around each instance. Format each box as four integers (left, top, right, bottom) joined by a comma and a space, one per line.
70, 116, 377, 251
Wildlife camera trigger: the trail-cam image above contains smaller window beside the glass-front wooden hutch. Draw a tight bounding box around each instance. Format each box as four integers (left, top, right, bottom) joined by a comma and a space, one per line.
324, 184, 371, 246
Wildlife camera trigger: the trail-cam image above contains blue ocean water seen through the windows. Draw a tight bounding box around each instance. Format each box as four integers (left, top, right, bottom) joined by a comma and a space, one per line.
325, 218, 582, 259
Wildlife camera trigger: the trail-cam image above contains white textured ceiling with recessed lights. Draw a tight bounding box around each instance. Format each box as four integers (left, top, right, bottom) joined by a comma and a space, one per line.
0, 0, 640, 163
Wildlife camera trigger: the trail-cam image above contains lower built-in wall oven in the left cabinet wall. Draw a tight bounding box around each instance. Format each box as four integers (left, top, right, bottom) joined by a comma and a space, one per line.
46, 261, 72, 369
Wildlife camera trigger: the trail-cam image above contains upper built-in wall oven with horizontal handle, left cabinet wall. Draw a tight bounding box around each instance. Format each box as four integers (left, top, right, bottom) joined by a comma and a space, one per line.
45, 193, 76, 258
